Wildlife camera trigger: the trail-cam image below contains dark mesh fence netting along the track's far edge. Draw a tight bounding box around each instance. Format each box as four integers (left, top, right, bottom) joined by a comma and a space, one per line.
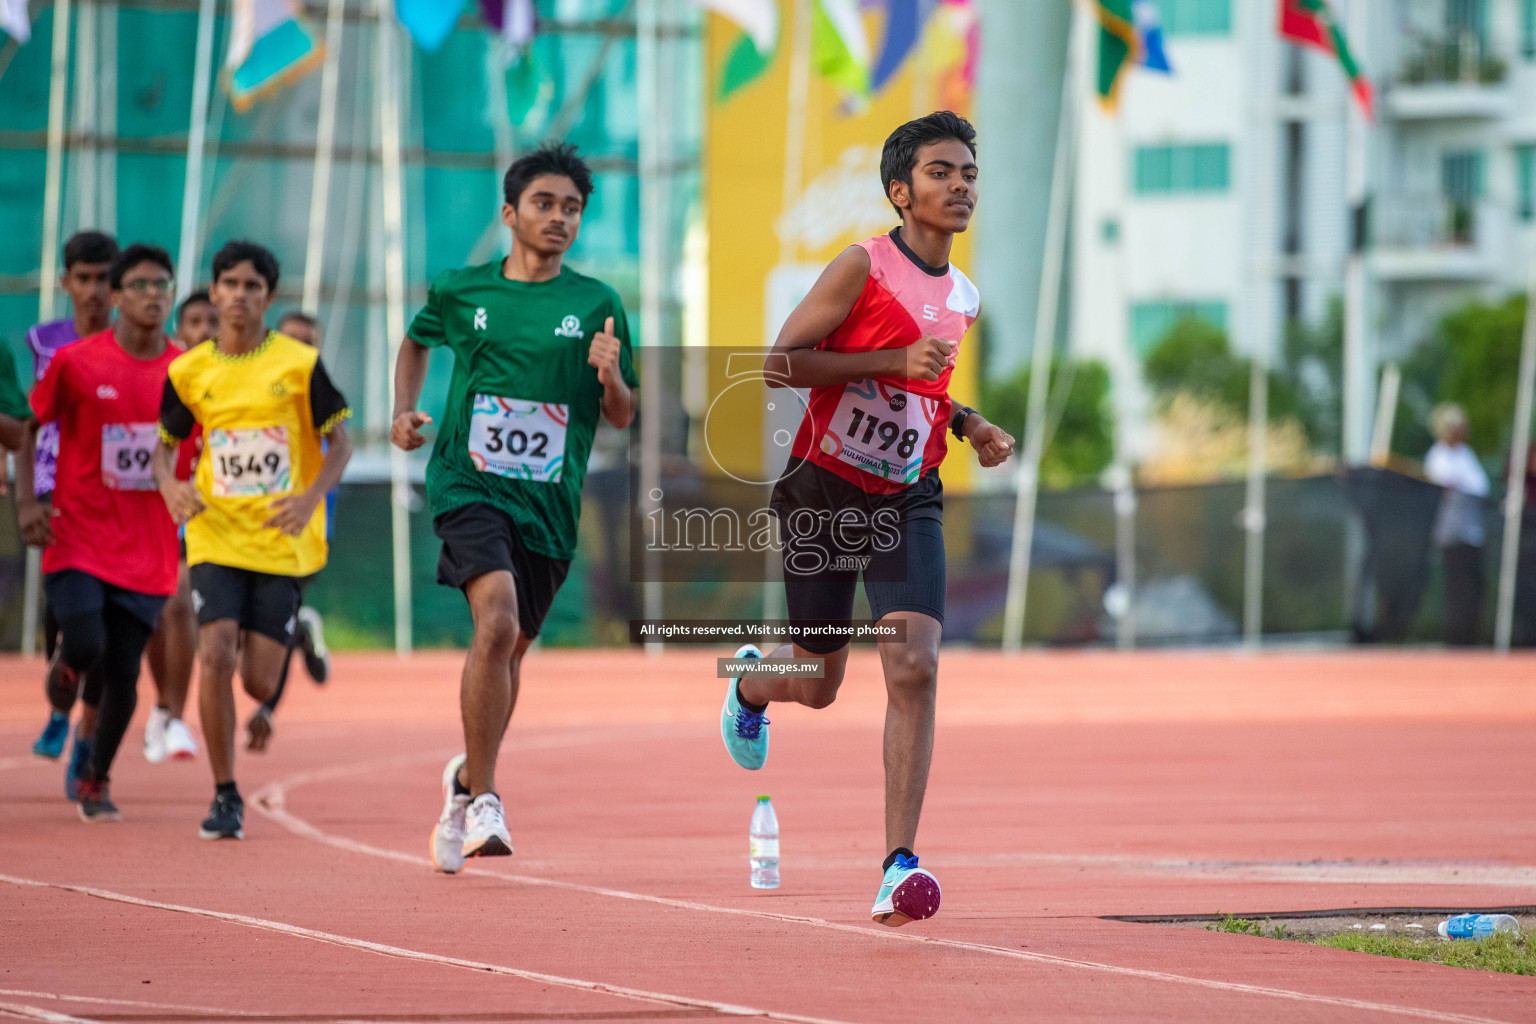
0, 464, 1536, 651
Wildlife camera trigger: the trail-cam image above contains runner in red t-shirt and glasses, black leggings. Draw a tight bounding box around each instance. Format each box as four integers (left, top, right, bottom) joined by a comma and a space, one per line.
18, 246, 180, 821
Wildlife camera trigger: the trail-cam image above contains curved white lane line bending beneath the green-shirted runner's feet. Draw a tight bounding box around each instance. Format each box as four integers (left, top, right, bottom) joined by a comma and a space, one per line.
245, 752, 1507, 1024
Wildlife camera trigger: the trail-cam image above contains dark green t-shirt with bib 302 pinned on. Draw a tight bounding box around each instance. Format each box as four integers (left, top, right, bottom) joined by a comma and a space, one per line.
407, 259, 639, 559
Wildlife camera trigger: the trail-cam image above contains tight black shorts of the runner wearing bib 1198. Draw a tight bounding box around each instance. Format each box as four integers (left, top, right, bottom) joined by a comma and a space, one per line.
783, 517, 945, 654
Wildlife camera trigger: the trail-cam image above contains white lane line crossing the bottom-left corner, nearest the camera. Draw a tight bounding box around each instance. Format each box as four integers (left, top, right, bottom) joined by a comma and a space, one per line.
0, 875, 848, 1024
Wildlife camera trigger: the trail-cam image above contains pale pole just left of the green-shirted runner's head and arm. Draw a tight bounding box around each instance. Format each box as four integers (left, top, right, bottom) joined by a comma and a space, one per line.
378, 0, 412, 659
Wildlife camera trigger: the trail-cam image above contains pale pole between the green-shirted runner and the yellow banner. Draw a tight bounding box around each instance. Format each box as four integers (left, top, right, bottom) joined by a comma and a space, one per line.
634, 0, 665, 656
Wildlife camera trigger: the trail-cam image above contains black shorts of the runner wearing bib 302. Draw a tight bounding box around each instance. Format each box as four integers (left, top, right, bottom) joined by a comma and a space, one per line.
432, 502, 571, 640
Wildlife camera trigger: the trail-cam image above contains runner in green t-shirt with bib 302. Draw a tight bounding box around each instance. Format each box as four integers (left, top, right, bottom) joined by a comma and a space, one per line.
390, 143, 639, 874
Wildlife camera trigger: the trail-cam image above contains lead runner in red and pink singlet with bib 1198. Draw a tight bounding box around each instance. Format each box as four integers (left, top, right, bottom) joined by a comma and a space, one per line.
720, 111, 1014, 926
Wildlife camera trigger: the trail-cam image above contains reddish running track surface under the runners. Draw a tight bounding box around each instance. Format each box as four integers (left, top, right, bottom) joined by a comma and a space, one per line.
0, 651, 1536, 1024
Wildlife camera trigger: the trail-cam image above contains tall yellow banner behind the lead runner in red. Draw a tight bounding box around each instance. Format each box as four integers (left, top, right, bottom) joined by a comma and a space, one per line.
703, 0, 986, 491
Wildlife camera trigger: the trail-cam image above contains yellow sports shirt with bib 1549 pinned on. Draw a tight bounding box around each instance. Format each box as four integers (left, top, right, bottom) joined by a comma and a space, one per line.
170, 332, 332, 576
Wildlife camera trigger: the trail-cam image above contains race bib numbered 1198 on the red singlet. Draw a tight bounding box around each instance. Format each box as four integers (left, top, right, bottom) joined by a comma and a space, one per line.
820, 381, 934, 484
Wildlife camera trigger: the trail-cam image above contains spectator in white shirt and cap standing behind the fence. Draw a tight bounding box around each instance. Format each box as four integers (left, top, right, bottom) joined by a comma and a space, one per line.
1424, 402, 1488, 646
